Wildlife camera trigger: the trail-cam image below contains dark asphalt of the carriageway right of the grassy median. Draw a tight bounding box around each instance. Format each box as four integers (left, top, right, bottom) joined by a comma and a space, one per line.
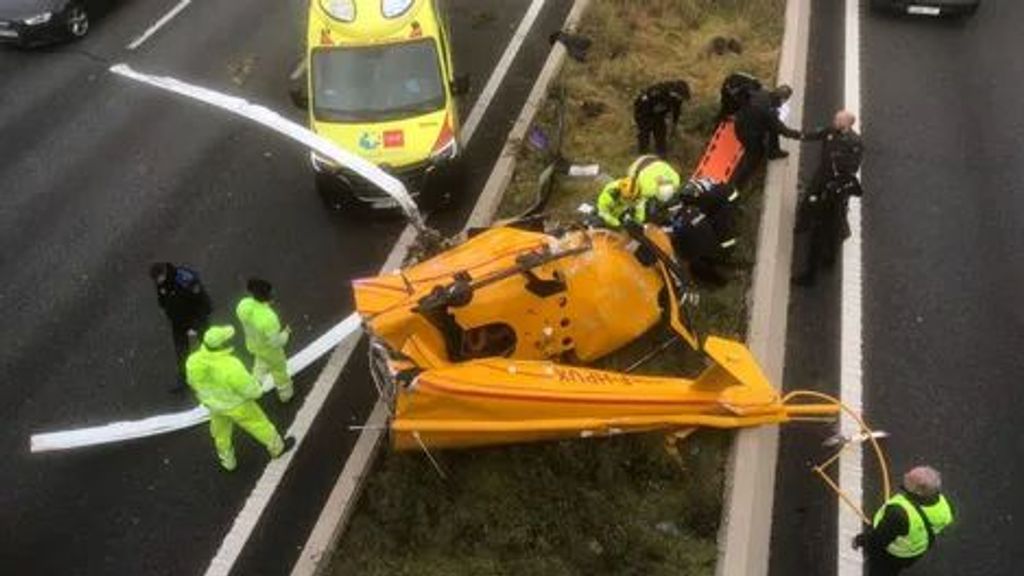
772, 1, 1024, 576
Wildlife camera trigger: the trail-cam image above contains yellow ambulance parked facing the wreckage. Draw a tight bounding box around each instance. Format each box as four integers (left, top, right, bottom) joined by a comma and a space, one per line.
305, 0, 468, 208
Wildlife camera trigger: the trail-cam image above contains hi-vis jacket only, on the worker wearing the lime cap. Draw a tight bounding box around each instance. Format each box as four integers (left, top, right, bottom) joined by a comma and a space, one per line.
185, 344, 263, 413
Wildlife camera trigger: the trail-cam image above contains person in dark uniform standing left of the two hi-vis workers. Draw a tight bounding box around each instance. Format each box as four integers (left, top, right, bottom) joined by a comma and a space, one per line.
150, 262, 213, 392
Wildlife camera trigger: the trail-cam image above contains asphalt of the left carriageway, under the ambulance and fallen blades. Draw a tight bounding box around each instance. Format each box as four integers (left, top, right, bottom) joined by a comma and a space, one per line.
0, 0, 571, 575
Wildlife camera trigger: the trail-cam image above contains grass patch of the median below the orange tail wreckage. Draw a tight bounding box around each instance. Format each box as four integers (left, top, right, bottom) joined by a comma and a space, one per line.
334, 431, 728, 576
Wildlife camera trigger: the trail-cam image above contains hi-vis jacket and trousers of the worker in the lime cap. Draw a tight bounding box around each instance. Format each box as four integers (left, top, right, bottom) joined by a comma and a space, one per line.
185, 344, 285, 470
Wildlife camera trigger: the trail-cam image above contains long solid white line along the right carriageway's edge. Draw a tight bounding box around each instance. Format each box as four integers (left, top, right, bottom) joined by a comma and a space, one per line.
837, 0, 864, 576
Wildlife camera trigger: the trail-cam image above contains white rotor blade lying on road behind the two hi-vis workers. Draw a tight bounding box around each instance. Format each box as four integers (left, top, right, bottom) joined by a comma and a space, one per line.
30, 314, 362, 453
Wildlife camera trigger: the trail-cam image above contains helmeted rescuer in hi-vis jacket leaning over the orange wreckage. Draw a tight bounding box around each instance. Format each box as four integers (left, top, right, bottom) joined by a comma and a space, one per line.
597, 156, 681, 228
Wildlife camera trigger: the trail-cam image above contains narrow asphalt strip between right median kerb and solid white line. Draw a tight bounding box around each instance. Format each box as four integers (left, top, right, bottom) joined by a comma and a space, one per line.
769, 2, 845, 576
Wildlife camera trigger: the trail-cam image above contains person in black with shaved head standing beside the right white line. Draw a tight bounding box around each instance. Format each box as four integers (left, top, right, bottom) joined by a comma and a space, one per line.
795, 110, 864, 286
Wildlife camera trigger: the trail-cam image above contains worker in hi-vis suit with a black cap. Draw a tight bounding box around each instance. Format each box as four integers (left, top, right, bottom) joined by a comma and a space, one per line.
234, 278, 295, 402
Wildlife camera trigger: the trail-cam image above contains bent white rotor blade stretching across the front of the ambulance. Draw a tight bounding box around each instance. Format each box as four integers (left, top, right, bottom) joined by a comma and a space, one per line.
110, 64, 423, 230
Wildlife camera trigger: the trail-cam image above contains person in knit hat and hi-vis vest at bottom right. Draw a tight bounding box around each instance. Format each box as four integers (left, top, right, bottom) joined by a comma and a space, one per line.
853, 466, 953, 576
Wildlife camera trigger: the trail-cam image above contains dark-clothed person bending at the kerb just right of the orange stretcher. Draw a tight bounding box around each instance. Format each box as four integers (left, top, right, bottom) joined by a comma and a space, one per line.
733, 86, 801, 188
